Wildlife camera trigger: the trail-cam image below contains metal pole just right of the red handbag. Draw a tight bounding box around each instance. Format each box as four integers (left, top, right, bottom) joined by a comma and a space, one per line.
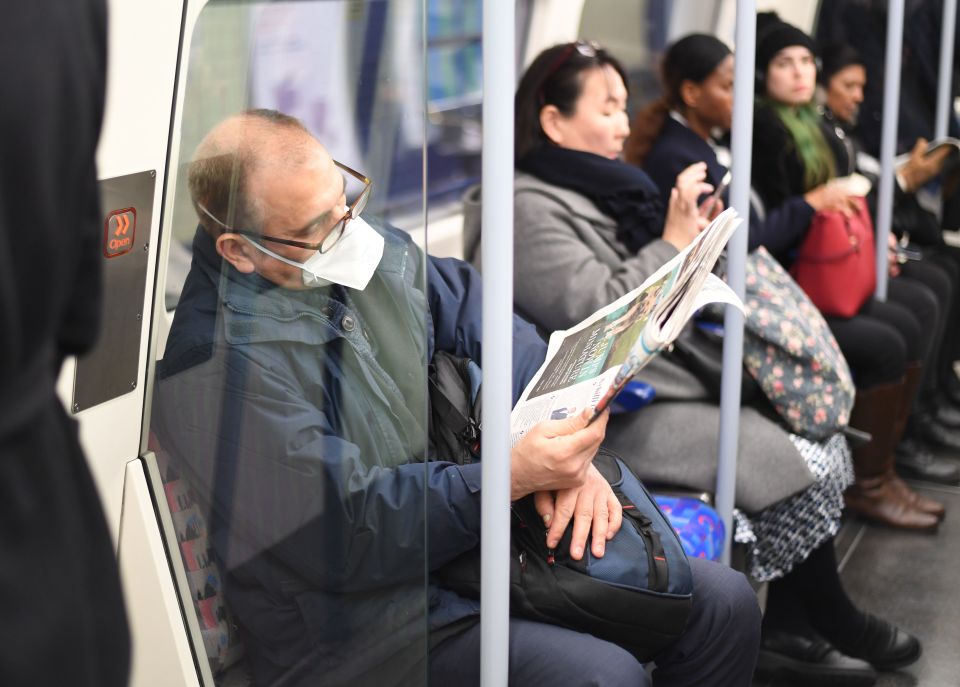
875, 0, 903, 301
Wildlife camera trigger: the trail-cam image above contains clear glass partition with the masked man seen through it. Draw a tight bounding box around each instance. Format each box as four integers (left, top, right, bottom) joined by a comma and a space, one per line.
149, 0, 432, 685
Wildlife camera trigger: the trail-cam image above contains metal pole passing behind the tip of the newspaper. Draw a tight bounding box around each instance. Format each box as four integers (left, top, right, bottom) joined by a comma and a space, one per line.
716, 0, 757, 565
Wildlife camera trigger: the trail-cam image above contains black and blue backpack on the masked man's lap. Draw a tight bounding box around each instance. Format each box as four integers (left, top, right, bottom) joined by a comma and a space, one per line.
430, 354, 693, 661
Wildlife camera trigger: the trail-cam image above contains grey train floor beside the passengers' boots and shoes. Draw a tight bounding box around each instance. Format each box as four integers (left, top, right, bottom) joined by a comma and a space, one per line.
753, 454, 960, 687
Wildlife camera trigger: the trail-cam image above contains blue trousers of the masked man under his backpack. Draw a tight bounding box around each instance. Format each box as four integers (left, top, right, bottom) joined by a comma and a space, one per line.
430, 559, 760, 687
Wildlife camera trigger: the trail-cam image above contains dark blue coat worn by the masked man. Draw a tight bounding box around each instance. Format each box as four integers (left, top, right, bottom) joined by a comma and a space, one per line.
153, 229, 546, 684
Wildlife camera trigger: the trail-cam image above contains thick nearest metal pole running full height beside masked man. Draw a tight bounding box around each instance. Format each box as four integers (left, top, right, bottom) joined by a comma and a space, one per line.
480, 0, 516, 687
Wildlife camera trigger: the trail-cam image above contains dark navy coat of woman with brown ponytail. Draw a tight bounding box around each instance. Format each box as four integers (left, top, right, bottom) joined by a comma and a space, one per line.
643, 117, 813, 262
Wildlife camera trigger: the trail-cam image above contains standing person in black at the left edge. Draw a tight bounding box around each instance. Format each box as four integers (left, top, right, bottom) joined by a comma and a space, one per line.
0, 0, 130, 687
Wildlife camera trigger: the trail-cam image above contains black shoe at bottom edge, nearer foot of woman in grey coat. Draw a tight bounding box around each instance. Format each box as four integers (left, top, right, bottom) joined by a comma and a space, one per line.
756, 630, 877, 687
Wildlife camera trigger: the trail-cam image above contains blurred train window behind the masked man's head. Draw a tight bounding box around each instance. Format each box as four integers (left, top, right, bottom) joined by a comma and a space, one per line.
164, 0, 533, 310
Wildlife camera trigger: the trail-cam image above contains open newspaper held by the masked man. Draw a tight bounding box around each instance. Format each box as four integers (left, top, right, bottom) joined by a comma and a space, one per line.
510, 208, 743, 443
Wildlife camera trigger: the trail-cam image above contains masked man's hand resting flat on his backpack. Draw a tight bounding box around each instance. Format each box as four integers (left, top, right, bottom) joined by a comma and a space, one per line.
533, 463, 623, 561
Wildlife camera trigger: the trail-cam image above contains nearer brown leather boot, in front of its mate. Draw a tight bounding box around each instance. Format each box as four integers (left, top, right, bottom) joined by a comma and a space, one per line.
844, 379, 940, 531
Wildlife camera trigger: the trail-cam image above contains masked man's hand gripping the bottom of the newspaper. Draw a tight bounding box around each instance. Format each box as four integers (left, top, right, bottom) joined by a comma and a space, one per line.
510, 409, 610, 501
